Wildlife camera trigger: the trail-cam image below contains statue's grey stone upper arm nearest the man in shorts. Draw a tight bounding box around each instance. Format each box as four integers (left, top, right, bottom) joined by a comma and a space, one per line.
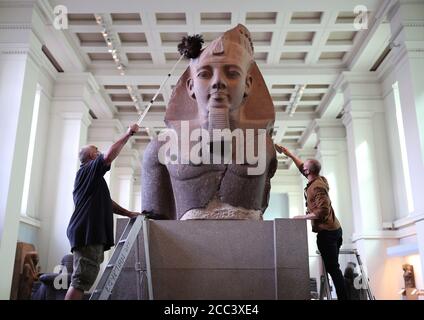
141, 139, 176, 220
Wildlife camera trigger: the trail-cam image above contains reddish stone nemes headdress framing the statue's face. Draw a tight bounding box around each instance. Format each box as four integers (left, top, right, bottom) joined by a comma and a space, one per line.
165, 24, 275, 129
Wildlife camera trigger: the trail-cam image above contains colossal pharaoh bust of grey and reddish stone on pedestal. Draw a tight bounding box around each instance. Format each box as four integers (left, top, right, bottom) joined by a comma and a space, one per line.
142, 25, 277, 220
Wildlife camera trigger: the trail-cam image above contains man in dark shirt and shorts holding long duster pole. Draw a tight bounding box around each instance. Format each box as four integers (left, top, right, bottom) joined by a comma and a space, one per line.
65, 124, 139, 300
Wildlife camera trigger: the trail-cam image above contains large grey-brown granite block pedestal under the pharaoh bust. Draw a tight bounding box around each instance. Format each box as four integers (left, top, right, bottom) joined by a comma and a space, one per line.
111, 219, 310, 300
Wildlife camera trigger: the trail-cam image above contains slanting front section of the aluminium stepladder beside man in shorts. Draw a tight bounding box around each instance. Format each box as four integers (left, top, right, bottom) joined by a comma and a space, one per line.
90, 215, 147, 300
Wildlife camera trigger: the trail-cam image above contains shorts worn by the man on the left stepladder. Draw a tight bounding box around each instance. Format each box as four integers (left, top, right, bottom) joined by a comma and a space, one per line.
71, 244, 104, 291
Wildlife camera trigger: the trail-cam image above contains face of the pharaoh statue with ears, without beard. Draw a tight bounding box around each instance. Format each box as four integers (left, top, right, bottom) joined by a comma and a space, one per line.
187, 44, 252, 120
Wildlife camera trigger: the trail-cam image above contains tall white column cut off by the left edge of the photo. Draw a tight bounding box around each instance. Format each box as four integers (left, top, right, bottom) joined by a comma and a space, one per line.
0, 1, 48, 299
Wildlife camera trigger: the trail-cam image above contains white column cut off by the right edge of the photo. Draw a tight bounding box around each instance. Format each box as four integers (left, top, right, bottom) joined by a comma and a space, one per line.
390, 1, 424, 215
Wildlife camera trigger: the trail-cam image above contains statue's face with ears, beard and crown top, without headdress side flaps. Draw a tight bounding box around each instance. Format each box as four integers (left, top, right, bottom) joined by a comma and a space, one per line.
186, 26, 253, 129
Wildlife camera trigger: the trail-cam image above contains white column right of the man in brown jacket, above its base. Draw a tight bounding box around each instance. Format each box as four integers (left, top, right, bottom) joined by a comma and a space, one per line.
343, 74, 394, 235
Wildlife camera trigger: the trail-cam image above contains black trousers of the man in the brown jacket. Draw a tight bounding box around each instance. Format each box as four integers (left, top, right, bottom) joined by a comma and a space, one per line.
317, 228, 347, 300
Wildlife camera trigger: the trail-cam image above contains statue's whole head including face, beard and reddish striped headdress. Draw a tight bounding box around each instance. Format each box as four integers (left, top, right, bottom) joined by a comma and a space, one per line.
165, 24, 275, 131
